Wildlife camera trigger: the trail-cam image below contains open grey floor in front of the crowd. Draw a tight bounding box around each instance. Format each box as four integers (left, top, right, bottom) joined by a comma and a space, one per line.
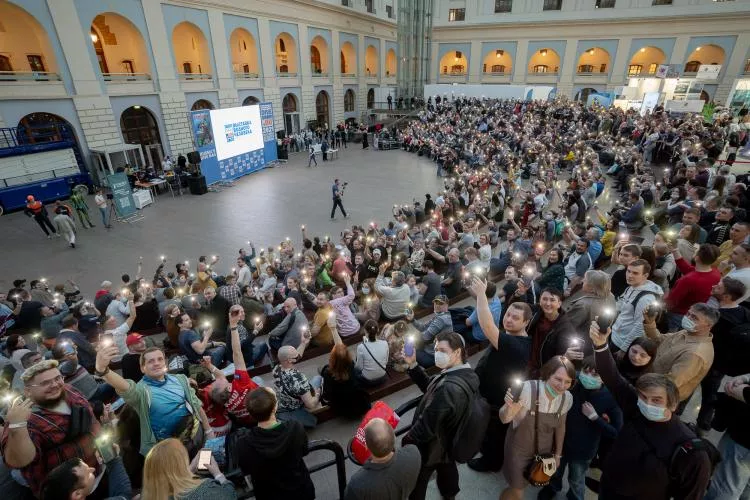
0, 147, 442, 297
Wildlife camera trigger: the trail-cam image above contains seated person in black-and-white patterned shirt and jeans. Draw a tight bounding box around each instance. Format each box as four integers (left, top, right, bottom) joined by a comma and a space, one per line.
273, 344, 323, 429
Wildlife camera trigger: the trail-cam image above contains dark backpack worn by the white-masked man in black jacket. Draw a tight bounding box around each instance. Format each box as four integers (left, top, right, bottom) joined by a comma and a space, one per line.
446, 377, 490, 464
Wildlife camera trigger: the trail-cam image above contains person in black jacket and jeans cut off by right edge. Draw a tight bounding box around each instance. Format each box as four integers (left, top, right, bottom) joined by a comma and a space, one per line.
705, 373, 750, 500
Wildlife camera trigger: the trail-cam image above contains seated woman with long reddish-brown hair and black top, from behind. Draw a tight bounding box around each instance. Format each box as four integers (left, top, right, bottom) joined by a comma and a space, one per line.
320, 342, 370, 418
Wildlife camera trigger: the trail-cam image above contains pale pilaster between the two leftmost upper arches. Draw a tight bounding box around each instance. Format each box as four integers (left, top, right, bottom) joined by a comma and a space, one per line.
47, 0, 102, 96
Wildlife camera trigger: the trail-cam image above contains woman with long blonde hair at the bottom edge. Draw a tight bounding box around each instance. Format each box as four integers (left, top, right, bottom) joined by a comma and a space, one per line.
141, 438, 237, 500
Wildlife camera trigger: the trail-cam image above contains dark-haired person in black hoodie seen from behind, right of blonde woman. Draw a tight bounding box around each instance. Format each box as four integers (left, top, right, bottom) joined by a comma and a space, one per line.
236, 387, 315, 500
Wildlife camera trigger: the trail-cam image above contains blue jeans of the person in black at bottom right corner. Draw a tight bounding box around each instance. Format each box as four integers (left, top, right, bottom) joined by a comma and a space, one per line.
704, 434, 750, 500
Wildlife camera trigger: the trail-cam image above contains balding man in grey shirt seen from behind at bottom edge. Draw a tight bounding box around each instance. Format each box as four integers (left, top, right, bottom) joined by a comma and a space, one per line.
344, 418, 422, 500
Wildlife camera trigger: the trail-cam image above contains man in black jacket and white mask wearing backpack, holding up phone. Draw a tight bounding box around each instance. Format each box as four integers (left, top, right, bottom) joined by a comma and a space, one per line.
401, 332, 479, 500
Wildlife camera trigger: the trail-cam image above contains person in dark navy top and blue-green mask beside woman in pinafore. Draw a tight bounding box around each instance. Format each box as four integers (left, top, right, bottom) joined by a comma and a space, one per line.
537, 356, 622, 500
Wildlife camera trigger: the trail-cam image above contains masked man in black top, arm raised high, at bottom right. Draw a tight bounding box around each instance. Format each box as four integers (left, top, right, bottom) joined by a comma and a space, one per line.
589, 321, 711, 500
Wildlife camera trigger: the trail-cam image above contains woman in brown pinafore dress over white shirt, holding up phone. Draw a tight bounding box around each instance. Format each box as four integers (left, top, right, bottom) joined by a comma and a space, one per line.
500, 356, 576, 500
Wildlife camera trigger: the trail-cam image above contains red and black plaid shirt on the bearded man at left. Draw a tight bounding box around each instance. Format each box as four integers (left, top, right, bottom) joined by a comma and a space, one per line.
0, 384, 100, 498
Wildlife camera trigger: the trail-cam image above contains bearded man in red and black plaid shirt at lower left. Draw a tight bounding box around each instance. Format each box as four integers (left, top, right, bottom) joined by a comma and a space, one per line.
0, 360, 107, 498
